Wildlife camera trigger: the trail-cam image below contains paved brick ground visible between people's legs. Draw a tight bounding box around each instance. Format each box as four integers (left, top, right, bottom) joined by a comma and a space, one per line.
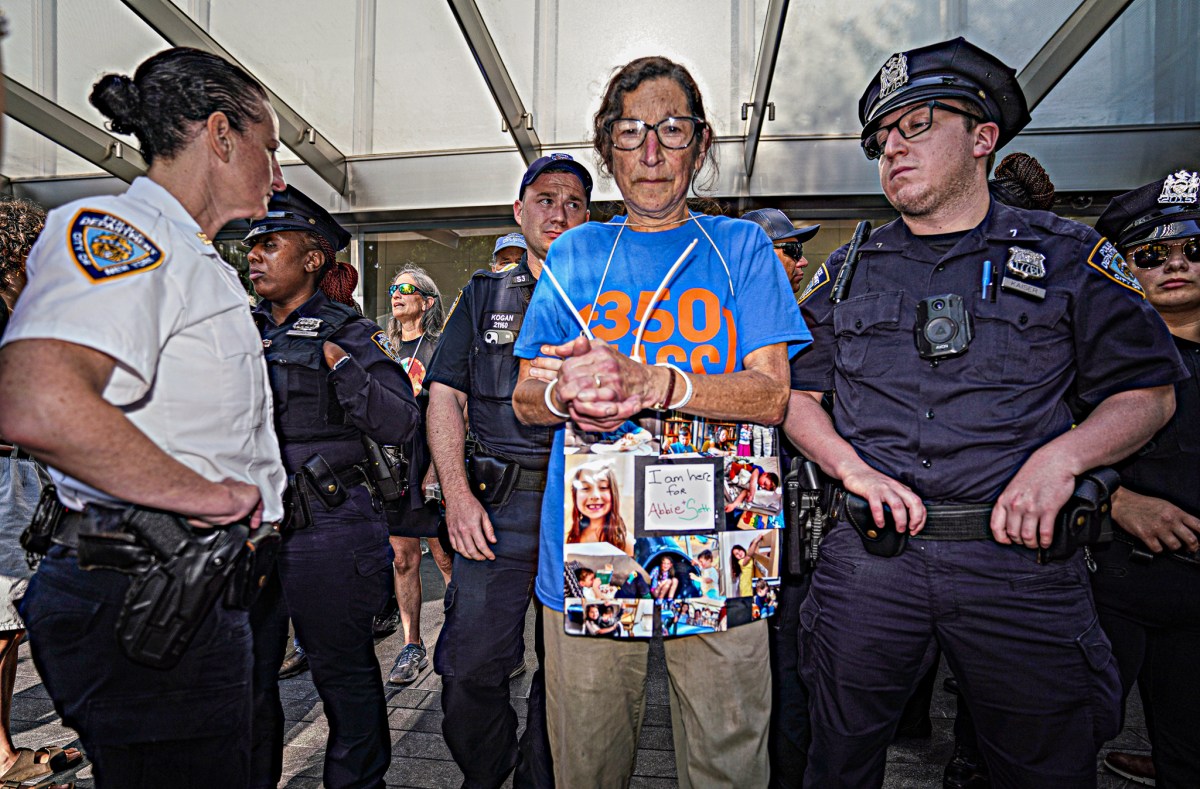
12, 556, 1150, 789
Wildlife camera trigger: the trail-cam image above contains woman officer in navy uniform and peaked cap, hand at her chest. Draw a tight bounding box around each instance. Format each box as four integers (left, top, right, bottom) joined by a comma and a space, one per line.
245, 187, 420, 789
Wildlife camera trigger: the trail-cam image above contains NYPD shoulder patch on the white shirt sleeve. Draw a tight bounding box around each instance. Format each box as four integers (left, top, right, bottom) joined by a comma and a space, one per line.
67, 209, 163, 283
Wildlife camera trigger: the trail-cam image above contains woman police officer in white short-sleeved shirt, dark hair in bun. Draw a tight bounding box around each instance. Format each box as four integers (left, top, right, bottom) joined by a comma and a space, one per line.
0, 49, 284, 789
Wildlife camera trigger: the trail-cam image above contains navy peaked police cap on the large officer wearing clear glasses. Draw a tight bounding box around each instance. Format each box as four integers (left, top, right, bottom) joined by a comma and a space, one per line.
858, 36, 1030, 150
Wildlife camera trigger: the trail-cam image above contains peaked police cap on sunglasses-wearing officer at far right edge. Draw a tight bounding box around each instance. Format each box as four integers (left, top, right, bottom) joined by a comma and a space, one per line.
1096, 170, 1200, 247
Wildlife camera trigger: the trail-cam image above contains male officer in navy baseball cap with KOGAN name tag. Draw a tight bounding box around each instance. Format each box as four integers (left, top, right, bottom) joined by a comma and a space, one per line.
426, 153, 595, 788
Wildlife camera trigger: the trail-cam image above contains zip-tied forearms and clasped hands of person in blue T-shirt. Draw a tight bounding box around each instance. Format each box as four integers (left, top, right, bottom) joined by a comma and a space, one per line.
512, 337, 788, 430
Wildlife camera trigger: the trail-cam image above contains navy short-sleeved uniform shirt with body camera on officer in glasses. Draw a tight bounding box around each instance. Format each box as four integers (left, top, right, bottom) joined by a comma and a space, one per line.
792, 200, 1186, 504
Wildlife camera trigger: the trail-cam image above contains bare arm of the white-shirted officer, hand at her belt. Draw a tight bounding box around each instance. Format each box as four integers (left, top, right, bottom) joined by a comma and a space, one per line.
0, 339, 260, 524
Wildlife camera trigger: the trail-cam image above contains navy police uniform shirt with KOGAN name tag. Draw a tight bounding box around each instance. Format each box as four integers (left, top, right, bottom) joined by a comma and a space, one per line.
426, 257, 553, 468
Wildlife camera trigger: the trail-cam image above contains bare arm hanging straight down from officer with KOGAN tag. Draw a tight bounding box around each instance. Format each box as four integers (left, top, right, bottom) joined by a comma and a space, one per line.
425, 381, 496, 561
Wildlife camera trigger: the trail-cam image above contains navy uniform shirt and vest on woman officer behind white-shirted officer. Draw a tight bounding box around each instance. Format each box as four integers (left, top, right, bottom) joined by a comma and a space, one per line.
254, 290, 420, 474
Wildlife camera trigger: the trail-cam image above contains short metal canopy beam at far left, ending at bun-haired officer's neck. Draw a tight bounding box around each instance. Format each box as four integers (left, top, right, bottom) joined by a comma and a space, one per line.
4, 74, 146, 181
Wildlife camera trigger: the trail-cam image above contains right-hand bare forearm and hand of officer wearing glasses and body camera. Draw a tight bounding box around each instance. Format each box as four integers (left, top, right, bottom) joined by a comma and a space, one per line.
991, 386, 1175, 548
